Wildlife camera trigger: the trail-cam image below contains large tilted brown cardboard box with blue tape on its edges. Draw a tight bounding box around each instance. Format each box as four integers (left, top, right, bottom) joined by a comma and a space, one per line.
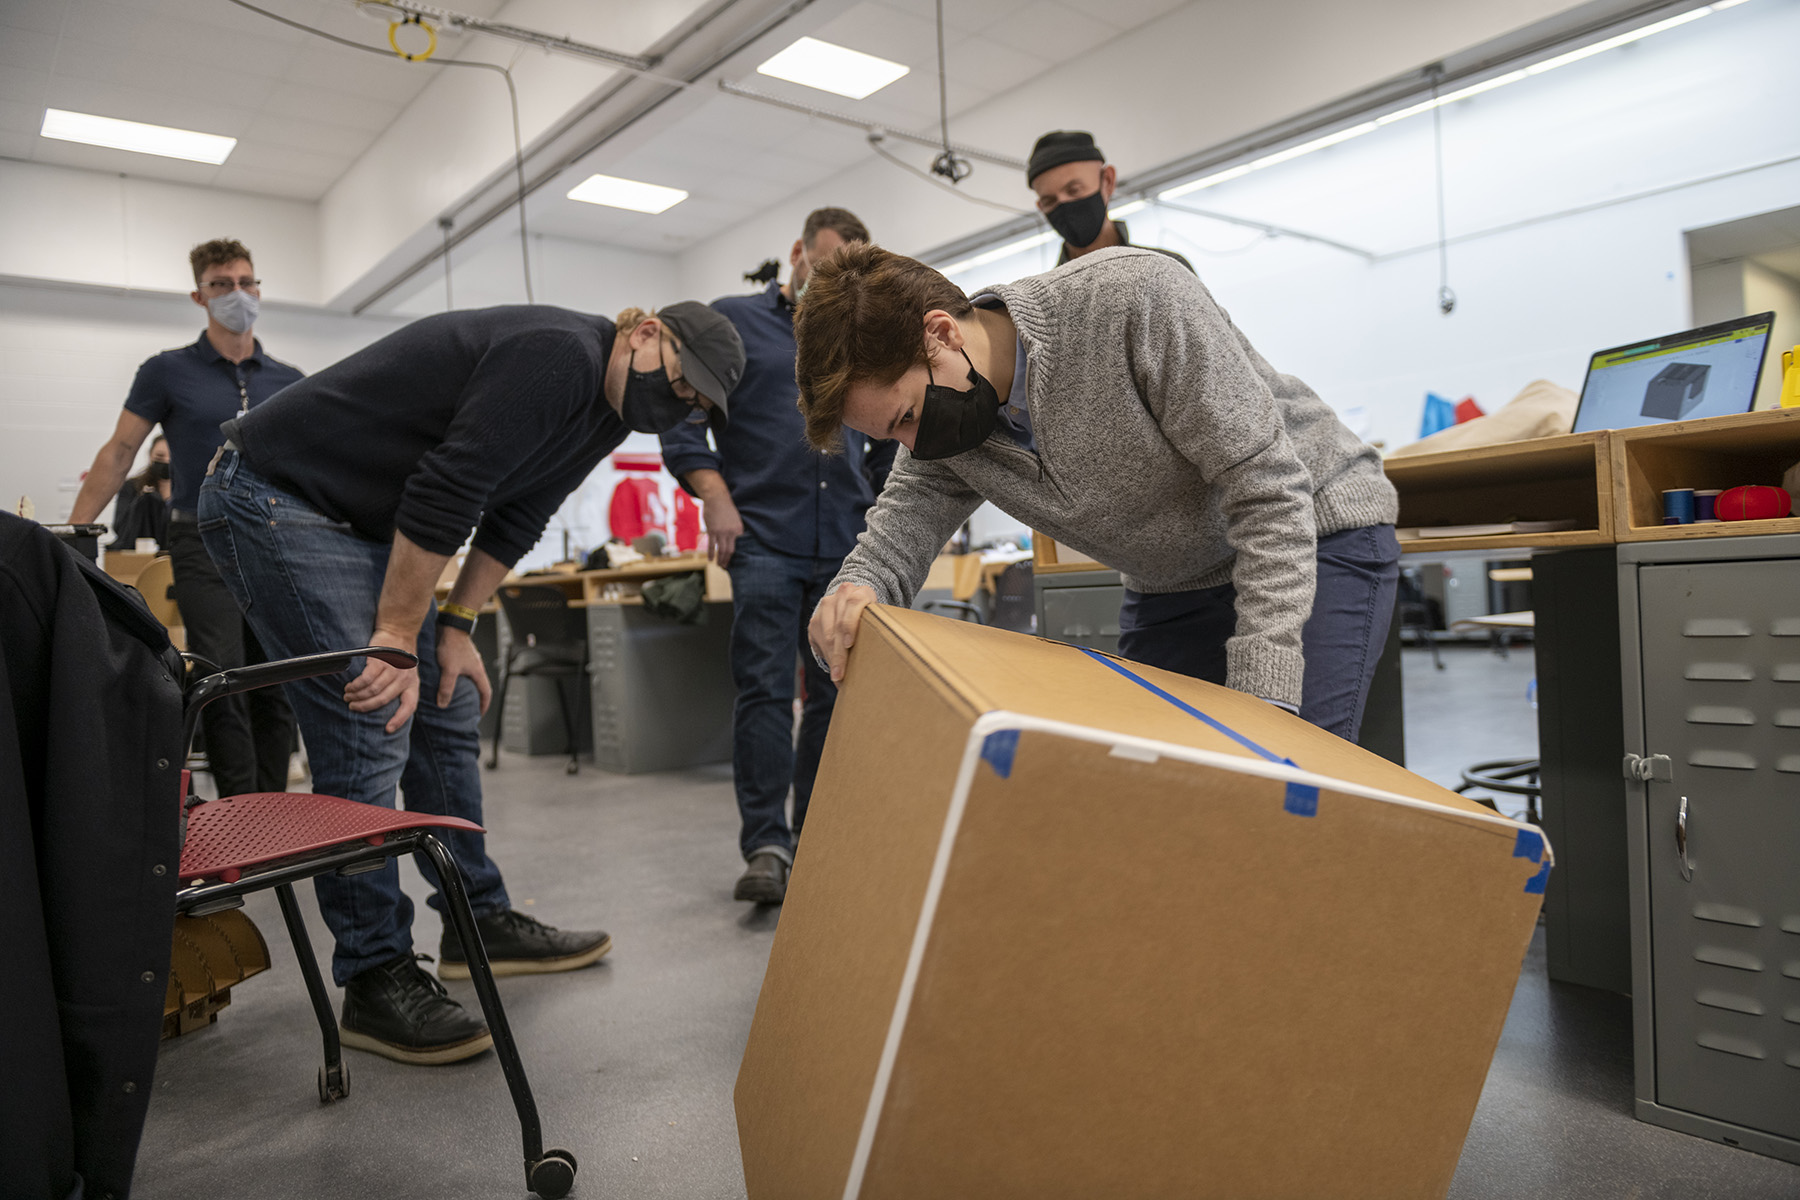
736, 608, 1550, 1200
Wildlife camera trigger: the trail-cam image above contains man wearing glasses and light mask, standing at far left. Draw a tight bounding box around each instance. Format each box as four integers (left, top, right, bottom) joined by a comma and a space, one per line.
68, 237, 301, 795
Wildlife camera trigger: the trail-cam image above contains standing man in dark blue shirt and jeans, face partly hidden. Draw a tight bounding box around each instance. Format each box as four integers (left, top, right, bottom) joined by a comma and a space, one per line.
662, 209, 895, 903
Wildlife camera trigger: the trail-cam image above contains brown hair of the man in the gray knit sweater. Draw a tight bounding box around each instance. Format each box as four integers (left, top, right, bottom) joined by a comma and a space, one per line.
794, 243, 974, 453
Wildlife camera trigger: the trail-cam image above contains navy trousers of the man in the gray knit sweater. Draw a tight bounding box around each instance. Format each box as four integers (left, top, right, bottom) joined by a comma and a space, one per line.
1120, 525, 1400, 741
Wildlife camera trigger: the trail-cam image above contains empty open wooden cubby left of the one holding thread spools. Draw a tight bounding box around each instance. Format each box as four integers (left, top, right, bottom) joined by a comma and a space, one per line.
1382, 432, 1615, 554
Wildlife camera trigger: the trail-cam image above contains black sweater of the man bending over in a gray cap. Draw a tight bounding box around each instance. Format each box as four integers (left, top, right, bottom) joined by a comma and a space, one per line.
220, 304, 628, 567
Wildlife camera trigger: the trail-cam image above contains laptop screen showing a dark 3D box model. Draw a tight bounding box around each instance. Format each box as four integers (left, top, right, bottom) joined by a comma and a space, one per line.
1575, 313, 1775, 434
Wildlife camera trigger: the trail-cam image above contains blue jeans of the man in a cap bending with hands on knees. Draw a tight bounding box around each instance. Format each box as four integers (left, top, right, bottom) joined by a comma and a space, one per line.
200, 450, 511, 984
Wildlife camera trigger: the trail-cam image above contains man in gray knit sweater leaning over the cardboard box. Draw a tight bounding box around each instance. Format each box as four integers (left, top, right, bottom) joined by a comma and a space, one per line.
794, 246, 1399, 739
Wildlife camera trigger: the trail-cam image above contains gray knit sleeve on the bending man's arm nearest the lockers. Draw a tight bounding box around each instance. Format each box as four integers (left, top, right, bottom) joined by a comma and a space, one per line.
1127, 263, 1318, 707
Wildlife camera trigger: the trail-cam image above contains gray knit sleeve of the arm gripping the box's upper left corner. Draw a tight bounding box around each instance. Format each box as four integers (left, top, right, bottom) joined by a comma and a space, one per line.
826, 448, 981, 608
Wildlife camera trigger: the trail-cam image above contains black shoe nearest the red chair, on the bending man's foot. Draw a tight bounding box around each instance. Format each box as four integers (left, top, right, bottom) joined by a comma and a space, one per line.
338, 954, 493, 1063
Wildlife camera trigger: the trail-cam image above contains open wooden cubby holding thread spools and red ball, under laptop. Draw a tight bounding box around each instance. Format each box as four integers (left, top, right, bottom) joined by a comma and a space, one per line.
1611, 408, 1800, 542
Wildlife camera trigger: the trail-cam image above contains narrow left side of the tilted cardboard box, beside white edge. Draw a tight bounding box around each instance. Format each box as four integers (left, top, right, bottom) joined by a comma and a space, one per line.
736, 624, 976, 1198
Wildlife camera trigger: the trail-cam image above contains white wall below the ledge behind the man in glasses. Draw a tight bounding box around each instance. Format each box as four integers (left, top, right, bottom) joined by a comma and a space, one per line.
0, 284, 403, 522
